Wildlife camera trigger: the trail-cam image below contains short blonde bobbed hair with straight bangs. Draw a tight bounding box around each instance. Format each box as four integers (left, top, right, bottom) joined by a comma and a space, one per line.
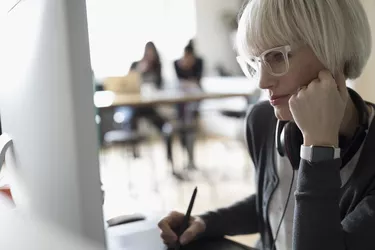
236, 0, 372, 79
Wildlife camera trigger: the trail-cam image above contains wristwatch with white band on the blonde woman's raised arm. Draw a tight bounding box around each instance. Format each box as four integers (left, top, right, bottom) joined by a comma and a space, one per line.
300, 145, 341, 162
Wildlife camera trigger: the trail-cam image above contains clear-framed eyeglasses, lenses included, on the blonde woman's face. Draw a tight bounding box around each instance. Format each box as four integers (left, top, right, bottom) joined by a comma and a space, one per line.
236, 45, 291, 79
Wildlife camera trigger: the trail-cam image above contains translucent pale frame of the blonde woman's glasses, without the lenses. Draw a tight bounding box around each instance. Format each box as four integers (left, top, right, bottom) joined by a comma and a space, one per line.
236, 45, 292, 79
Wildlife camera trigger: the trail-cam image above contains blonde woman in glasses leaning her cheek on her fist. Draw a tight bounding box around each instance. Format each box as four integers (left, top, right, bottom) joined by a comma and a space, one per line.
159, 0, 375, 250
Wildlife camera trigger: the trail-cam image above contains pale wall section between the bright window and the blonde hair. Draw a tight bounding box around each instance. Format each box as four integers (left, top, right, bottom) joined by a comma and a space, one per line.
195, 0, 241, 76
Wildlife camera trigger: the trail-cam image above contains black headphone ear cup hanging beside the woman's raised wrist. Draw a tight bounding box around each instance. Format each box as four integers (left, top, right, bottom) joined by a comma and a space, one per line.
281, 122, 303, 170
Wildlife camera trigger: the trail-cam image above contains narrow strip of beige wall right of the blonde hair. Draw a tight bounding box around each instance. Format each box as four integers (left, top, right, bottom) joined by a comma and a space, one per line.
355, 0, 375, 102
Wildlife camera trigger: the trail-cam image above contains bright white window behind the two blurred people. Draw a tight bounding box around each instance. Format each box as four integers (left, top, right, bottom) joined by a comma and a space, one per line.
86, 0, 196, 78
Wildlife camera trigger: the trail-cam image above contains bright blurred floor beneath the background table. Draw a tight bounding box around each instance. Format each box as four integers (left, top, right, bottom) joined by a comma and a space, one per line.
100, 138, 257, 246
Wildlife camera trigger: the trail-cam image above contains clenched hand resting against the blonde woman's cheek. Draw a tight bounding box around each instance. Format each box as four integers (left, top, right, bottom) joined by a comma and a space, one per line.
289, 70, 349, 147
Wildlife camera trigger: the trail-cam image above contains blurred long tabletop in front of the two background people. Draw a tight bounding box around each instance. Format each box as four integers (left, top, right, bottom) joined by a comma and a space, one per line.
94, 90, 251, 108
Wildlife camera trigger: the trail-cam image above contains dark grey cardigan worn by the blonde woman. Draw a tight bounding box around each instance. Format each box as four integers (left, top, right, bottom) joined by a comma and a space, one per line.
201, 102, 375, 250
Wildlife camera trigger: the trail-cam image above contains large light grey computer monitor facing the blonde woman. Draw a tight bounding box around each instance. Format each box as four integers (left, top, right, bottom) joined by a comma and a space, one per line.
0, 0, 105, 246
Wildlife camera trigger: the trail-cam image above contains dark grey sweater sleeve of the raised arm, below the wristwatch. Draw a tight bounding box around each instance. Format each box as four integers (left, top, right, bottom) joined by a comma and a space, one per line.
293, 159, 375, 250
